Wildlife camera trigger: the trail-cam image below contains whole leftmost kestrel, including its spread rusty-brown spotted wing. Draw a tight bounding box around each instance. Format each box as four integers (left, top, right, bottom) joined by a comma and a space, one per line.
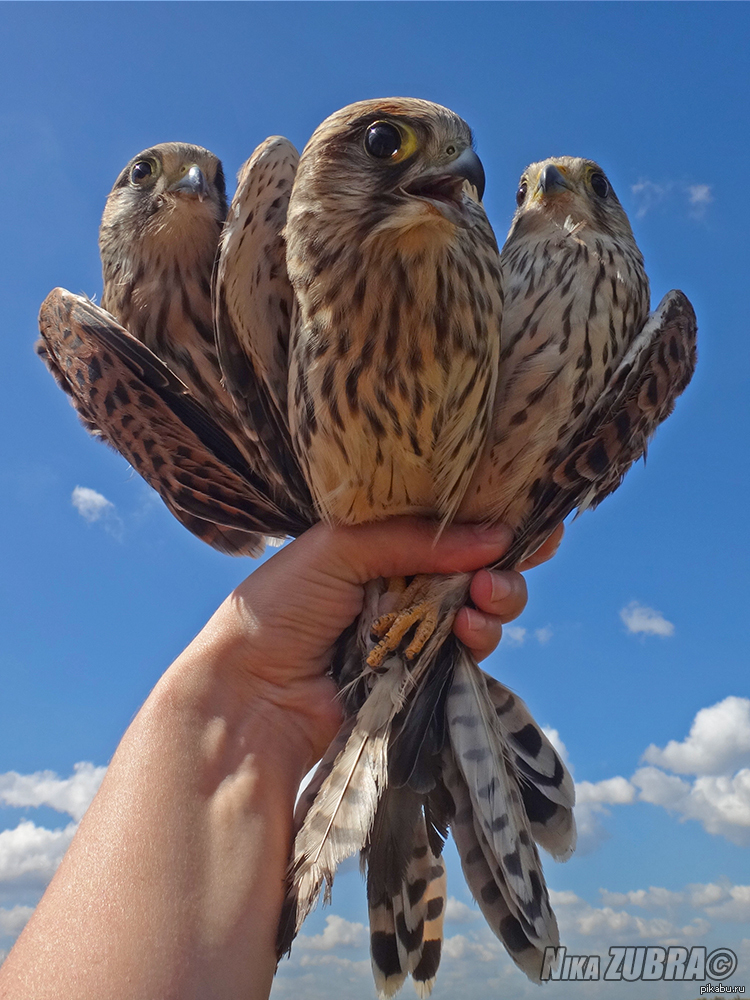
38, 142, 312, 555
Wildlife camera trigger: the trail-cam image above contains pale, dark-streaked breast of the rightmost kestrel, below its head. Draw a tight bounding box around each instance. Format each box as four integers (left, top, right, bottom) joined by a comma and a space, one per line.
461, 238, 648, 527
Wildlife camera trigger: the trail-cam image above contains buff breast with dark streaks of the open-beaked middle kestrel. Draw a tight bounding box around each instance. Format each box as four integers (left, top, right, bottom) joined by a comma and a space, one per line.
290, 244, 501, 523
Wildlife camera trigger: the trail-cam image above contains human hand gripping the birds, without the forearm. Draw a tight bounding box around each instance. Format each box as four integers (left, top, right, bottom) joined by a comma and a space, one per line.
191, 518, 560, 757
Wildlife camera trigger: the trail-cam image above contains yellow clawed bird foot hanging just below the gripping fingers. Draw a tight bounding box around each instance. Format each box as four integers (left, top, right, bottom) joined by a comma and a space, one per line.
367, 574, 440, 667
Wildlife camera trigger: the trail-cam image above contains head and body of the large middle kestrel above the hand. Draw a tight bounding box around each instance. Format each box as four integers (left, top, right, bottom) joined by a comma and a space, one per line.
286, 100, 502, 523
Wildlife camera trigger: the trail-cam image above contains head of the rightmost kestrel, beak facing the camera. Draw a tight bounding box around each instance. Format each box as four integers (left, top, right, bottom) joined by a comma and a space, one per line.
511, 156, 633, 241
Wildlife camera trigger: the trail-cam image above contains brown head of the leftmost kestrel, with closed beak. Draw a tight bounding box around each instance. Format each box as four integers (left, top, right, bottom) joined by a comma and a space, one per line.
99, 142, 227, 281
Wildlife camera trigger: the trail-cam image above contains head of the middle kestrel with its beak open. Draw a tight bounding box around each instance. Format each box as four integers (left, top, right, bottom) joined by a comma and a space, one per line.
292, 97, 484, 238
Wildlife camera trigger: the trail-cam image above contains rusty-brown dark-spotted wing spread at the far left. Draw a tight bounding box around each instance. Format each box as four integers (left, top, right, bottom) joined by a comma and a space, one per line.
37, 288, 309, 555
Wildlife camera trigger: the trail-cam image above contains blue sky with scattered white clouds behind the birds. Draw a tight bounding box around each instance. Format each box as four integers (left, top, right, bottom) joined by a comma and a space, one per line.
0, 2, 750, 1000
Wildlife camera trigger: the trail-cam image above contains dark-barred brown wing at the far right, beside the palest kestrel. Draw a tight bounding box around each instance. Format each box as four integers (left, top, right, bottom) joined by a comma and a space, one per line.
498, 291, 698, 569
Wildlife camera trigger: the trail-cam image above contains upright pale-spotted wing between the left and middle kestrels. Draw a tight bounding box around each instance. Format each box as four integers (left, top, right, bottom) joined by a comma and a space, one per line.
214, 136, 311, 510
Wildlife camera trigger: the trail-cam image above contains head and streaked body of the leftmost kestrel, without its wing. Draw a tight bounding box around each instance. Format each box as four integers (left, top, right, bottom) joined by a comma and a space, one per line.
99, 142, 309, 551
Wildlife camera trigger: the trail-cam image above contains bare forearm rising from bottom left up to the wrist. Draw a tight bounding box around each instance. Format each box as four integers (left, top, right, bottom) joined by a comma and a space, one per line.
0, 612, 308, 1000
